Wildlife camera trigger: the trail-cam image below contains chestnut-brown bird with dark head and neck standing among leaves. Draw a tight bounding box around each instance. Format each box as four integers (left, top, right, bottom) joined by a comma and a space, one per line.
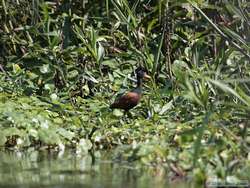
110, 67, 151, 112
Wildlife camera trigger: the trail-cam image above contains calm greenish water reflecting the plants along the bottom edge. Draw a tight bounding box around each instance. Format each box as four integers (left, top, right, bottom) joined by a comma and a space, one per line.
0, 151, 191, 188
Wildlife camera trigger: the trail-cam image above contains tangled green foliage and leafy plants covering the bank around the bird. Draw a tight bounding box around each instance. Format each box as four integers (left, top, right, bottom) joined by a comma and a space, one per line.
0, 0, 250, 182
